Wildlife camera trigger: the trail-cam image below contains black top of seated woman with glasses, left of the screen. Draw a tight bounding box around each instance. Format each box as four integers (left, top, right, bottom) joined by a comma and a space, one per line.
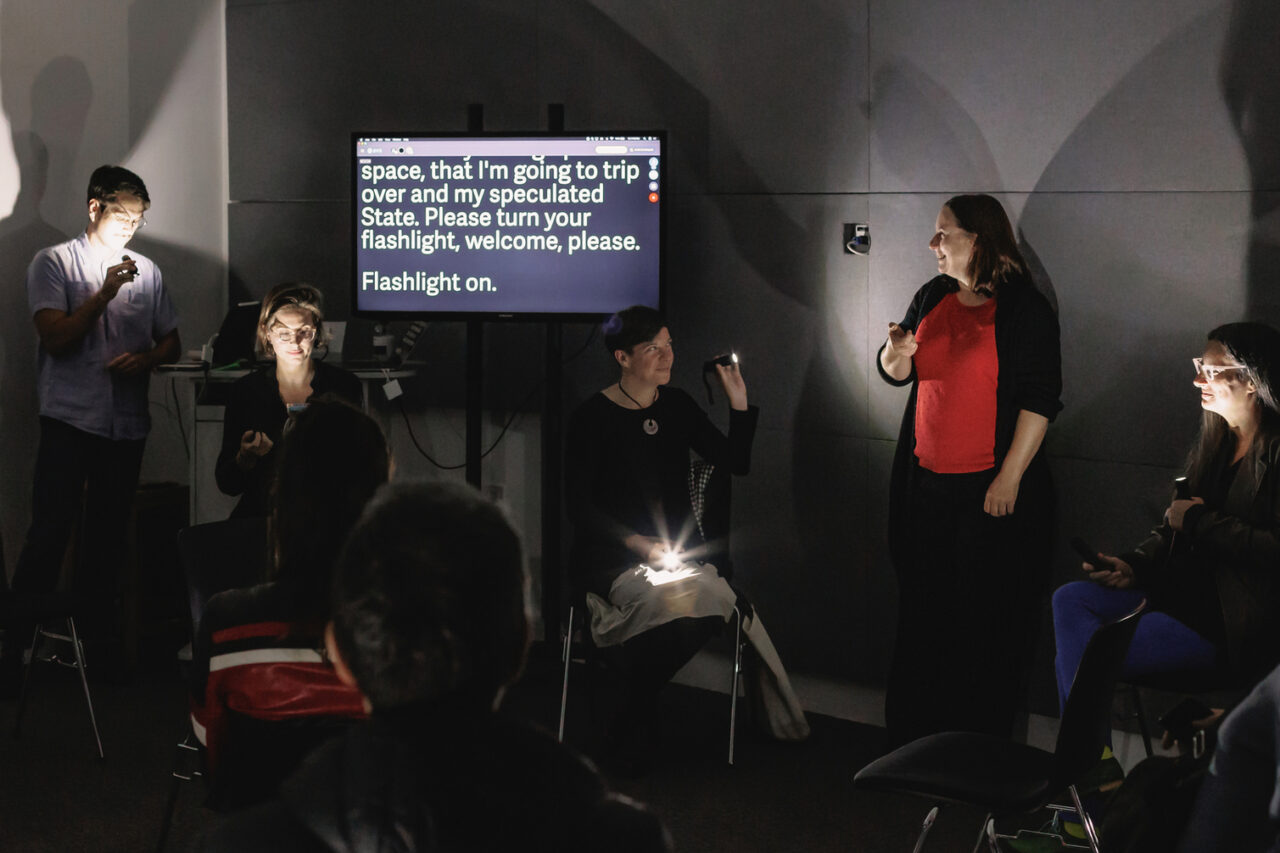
214, 361, 361, 519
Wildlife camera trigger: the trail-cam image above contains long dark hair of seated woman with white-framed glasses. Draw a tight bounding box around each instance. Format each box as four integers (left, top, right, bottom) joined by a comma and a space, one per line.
1187, 323, 1280, 494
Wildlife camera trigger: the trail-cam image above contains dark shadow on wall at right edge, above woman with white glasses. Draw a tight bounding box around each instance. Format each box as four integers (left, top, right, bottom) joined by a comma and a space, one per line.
1220, 0, 1280, 324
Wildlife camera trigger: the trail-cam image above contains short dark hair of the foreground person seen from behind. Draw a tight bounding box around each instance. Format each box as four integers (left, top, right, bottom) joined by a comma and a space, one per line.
333, 482, 531, 711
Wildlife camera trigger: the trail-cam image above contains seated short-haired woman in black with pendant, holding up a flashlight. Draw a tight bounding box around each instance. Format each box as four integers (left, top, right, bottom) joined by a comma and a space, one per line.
566, 306, 759, 751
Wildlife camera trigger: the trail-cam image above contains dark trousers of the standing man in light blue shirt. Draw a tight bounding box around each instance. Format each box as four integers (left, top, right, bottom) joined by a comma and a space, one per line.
13, 418, 146, 643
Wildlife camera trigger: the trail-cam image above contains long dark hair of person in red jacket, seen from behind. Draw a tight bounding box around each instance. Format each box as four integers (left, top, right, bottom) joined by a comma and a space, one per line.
269, 394, 390, 626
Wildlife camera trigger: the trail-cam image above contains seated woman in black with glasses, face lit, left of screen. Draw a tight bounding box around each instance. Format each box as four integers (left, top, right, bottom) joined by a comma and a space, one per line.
215, 283, 361, 519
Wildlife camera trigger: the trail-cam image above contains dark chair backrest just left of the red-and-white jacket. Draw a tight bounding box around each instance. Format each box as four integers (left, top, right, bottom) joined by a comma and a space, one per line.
178, 519, 268, 631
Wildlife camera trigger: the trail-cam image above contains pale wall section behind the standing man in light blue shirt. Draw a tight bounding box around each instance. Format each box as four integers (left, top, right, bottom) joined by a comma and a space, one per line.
0, 0, 227, 573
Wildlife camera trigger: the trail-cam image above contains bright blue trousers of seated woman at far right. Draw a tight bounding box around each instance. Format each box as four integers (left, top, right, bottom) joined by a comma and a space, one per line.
1053, 580, 1224, 711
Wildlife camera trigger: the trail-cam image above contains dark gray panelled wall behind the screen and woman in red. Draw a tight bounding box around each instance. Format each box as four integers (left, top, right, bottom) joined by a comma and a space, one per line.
0, 0, 1280, 704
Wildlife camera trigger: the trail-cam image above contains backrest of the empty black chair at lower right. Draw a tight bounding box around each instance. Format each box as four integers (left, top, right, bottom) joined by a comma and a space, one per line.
1051, 601, 1147, 789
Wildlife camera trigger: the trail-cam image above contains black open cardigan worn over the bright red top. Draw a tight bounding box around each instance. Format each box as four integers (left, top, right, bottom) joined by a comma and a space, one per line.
876, 275, 1062, 567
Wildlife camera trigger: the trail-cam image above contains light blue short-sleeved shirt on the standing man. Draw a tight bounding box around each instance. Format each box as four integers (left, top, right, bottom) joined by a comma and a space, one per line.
27, 234, 178, 439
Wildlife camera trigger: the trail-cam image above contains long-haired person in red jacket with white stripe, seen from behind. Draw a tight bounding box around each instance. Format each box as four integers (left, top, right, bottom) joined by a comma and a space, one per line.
192, 397, 390, 807
